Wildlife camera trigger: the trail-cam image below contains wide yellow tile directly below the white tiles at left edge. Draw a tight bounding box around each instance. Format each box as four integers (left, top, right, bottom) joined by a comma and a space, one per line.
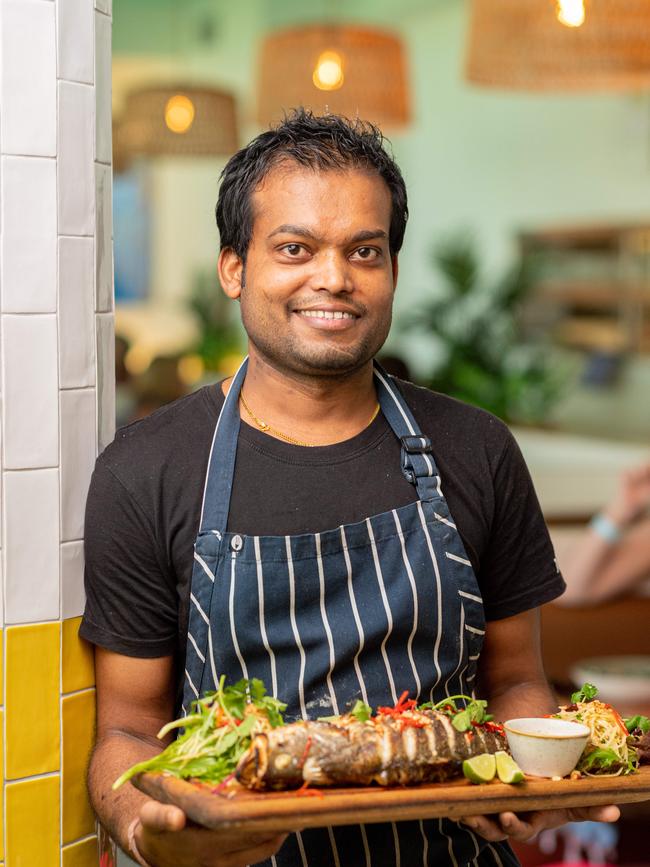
6, 623, 60, 780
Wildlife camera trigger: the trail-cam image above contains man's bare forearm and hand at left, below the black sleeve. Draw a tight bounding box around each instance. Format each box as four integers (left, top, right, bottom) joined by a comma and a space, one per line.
88, 647, 284, 867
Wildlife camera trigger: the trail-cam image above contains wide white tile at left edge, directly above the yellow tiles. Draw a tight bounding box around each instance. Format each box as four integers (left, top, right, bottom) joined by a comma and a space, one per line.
3, 470, 59, 623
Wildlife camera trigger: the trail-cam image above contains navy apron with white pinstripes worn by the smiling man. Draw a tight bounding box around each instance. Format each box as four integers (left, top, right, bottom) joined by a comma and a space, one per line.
183, 362, 517, 867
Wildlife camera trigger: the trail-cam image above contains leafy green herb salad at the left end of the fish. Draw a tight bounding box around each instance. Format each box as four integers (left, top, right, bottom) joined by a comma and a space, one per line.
113, 677, 286, 789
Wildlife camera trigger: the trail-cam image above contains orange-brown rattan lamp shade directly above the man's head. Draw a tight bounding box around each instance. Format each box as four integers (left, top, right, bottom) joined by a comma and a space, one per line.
257, 25, 409, 127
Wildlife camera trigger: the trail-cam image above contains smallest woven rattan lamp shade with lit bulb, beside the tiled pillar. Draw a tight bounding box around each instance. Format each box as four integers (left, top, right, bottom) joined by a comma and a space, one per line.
114, 87, 238, 162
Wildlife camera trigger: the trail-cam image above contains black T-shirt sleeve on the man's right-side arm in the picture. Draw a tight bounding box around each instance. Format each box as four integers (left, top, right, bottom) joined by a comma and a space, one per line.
480, 432, 566, 620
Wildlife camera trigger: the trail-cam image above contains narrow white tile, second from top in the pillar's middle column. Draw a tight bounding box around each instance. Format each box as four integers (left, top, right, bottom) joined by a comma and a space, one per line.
57, 81, 95, 235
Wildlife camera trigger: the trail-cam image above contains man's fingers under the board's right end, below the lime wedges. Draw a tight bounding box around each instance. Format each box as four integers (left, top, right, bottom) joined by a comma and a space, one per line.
460, 805, 621, 843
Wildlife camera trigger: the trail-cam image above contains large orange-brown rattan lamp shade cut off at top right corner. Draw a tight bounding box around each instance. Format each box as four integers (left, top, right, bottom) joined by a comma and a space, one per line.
467, 0, 650, 91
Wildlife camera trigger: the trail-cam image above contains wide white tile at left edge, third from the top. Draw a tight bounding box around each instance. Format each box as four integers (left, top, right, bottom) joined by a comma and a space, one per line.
2, 313, 59, 472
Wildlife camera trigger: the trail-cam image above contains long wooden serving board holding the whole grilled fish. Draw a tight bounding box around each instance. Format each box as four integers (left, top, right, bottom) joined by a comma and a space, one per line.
132, 766, 650, 832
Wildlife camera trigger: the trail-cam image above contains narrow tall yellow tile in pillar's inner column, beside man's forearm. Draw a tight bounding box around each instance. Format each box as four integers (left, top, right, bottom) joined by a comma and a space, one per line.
61, 689, 95, 843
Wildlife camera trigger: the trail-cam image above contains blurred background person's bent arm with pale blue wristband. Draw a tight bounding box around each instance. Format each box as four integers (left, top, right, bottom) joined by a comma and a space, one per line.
557, 461, 650, 606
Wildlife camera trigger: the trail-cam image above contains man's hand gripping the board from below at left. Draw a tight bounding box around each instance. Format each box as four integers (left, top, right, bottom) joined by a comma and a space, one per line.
134, 801, 286, 867
